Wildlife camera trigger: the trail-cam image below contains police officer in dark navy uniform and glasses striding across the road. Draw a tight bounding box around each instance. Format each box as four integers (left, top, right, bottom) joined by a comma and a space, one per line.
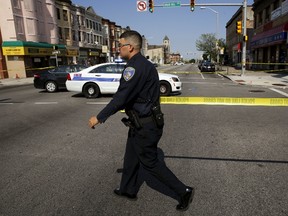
89, 31, 194, 211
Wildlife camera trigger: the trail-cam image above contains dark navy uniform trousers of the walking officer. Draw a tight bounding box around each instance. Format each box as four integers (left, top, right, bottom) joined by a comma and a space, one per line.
120, 122, 186, 196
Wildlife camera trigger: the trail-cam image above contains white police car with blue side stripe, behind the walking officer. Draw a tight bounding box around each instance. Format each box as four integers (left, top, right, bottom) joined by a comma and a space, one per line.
66, 63, 182, 98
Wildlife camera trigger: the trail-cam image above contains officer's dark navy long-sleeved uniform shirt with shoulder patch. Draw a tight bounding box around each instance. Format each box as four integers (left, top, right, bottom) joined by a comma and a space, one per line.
97, 52, 160, 123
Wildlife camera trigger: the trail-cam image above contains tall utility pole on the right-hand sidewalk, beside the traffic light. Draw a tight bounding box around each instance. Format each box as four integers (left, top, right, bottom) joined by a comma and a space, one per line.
241, 0, 247, 76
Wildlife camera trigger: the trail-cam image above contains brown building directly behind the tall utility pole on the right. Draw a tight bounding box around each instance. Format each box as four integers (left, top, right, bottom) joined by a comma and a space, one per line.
225, 5, 254, 68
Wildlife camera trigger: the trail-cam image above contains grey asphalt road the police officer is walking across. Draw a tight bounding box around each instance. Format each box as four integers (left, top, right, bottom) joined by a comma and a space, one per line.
0, 65, 288, 216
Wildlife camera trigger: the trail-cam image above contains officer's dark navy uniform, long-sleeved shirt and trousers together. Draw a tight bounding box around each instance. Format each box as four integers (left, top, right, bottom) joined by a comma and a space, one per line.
97, 53, 186, 196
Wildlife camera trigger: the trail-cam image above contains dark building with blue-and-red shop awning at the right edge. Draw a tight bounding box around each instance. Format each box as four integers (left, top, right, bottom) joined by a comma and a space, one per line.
251, 0, 288, 69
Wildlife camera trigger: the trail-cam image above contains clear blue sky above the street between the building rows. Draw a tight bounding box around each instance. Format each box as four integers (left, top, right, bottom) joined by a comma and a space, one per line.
72, 0, 253, 60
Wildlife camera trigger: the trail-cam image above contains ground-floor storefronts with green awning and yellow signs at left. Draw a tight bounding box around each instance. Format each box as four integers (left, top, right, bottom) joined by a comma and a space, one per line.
2, 41, 78, 78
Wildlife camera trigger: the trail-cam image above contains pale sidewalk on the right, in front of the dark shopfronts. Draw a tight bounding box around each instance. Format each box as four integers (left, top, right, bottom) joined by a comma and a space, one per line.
219, 66, 288, 89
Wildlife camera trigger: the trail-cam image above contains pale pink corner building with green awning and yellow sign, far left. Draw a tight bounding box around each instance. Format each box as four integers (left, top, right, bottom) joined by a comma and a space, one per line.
0, 0, 58, 78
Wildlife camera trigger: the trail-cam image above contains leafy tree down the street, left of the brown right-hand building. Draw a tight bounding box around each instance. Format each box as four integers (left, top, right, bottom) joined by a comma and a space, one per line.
196, 34, 226, 62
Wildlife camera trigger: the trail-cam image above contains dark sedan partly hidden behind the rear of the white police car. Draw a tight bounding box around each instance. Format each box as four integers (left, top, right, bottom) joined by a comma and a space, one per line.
34, 65, 87, 92
